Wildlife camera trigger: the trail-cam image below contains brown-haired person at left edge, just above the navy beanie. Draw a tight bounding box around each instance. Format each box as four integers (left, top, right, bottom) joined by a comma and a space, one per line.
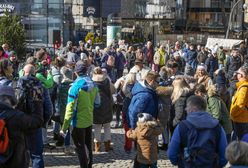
0, 59, 14, 86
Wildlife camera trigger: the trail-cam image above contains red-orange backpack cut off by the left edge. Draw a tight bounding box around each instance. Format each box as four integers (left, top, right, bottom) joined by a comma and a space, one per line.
0, 111, 16, 164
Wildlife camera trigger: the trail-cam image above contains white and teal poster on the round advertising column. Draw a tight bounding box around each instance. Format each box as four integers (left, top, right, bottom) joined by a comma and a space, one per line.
107, 26, 121, 46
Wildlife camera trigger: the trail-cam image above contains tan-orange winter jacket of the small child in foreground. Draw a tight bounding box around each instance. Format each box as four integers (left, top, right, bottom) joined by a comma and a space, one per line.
127, 121, 163, 164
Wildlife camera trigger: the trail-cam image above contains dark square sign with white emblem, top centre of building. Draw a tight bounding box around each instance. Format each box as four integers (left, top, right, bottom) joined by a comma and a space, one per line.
83, 0, 100, 17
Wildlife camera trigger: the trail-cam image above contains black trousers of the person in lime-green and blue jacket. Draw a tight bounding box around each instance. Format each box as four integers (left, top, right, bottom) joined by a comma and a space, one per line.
72, 126, 92, 168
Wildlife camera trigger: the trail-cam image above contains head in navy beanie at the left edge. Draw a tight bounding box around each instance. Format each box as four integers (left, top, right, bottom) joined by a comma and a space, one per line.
0, 85, 17, 106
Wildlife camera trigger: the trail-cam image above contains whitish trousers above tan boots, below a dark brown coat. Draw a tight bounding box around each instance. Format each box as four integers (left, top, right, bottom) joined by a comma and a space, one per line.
94, 123, 111, 142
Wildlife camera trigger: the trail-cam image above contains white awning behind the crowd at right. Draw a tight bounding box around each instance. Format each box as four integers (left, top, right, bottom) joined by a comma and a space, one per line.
206, 38, 243, 49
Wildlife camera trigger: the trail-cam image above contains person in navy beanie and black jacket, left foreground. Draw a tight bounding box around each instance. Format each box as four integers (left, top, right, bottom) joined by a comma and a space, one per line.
0, 85, 44, 168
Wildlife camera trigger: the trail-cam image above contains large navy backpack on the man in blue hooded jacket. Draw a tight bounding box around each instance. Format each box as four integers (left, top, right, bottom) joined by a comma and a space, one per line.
179, 120, 221, 168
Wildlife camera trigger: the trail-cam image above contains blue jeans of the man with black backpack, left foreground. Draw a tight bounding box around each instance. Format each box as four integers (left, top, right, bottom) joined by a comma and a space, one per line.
27, 128, 44, 168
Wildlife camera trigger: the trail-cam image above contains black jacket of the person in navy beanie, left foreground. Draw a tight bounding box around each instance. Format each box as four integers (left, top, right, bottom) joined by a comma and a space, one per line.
0, 102, 43, 168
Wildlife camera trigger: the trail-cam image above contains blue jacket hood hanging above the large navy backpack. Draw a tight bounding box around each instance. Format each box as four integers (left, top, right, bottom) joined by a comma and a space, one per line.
186, 111, 219, 129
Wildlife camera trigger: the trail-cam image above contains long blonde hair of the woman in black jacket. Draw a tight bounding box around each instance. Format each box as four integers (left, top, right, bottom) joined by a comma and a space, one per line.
171, 77, 190, 104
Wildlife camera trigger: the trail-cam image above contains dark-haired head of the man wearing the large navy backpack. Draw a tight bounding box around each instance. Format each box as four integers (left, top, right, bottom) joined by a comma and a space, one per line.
185, 95, 207, 113
